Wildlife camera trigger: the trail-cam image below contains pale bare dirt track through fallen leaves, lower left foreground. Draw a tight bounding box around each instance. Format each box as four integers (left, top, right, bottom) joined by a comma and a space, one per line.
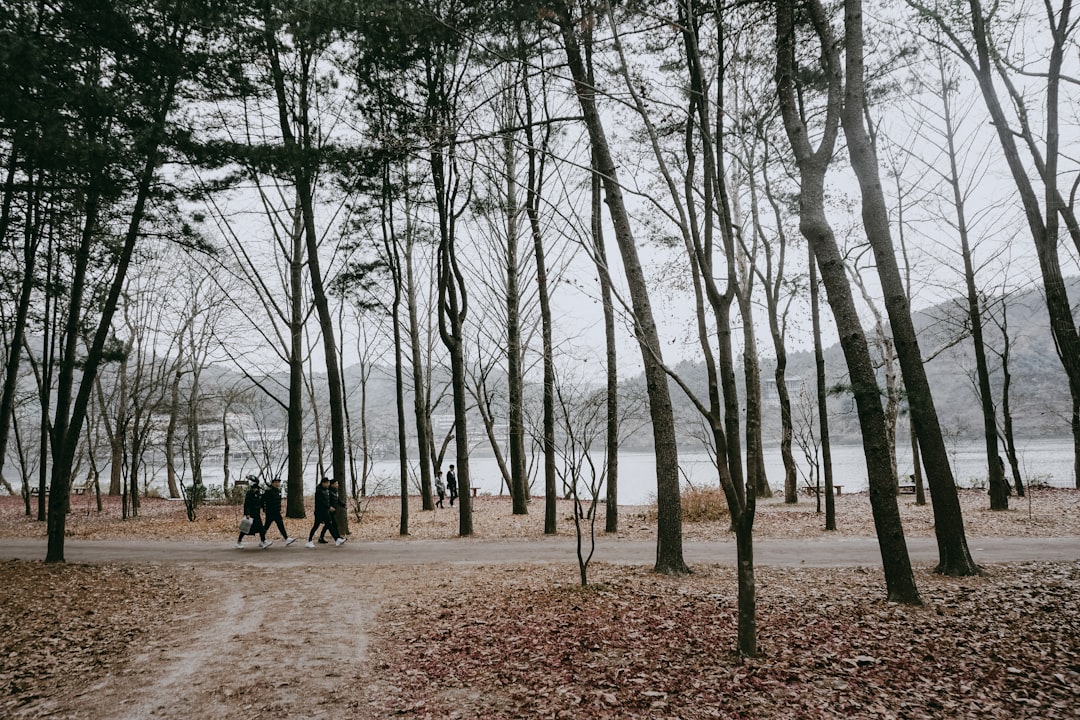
22, 565, 381, 720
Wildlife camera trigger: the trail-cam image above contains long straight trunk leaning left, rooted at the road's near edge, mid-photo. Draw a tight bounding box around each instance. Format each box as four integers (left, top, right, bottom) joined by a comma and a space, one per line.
555, 2, 689, 574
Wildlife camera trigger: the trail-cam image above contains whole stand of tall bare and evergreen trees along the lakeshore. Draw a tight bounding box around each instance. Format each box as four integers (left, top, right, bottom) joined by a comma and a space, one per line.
0, 0, 1080, 654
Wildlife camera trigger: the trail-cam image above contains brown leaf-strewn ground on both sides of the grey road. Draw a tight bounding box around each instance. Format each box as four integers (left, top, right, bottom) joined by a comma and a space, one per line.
0, 488, 1080, 720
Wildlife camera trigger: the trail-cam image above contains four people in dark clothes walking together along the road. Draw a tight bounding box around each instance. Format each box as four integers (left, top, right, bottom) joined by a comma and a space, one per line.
237, 475, 345, 548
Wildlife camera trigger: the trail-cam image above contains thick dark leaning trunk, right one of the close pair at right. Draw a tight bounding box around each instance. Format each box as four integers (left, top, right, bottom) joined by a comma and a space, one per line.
842, 0, 980, 575
